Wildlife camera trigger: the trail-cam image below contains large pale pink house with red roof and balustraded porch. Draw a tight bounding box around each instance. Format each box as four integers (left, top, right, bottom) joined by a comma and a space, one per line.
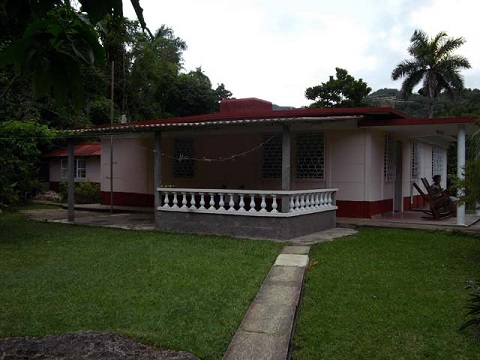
69, 98, 478, 238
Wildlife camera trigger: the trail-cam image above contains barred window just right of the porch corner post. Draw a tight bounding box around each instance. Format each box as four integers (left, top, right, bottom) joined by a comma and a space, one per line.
296, 133, 325, 180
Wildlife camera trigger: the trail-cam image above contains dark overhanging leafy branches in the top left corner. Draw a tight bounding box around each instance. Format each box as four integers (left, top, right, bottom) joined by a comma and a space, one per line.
0, 0, 150, 109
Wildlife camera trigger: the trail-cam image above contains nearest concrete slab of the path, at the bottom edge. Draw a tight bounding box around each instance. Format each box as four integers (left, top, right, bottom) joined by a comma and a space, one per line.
224, 331, 290, 360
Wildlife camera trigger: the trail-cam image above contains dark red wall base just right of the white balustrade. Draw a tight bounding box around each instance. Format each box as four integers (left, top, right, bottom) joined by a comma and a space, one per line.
337, 199, 393, 219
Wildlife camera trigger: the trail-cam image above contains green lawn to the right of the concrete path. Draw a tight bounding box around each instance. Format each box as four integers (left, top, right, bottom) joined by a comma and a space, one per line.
294, 229, 480, 360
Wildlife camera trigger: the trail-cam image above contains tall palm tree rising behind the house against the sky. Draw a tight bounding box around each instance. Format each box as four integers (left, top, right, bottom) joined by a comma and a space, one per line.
392, 30, 471, 117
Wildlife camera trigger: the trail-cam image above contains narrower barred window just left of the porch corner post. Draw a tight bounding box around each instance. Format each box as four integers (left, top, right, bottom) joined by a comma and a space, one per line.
262, 135, 282, 179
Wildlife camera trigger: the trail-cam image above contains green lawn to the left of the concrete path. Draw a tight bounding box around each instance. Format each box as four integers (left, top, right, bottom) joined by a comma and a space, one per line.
0, 213, 283, 359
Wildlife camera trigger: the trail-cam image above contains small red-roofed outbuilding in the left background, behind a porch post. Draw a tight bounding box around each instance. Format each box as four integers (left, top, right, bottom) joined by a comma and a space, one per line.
42, 142, 101, 191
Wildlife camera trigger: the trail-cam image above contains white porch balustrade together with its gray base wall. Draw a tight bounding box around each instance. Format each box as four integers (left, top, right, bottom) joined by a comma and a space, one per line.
155, 188, 337, 240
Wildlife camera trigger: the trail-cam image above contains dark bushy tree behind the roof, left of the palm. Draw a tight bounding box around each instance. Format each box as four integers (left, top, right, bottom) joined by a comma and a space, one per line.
305, 68, 372, 108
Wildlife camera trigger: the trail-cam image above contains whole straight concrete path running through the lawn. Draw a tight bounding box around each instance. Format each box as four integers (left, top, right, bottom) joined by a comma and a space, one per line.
224, 245, 310, 360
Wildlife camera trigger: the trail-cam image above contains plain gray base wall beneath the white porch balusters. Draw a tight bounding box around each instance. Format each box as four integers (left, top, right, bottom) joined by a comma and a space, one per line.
155, 210, 335, 240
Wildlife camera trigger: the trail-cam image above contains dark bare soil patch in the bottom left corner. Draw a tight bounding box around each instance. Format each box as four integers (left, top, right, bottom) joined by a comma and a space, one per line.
0, 331, 198, 360
